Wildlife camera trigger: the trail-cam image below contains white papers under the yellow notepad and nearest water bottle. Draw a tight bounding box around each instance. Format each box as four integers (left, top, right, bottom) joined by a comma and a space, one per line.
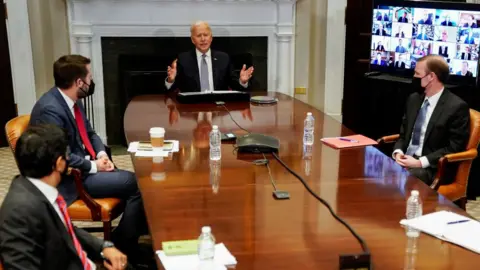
156, 243, 237, 270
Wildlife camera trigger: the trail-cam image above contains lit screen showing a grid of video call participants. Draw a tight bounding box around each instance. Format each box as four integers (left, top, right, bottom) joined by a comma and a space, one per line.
371, 6, 480, 77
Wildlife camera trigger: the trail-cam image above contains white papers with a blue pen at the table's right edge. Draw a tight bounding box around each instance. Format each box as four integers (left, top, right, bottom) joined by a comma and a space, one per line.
400, 211, 480, 253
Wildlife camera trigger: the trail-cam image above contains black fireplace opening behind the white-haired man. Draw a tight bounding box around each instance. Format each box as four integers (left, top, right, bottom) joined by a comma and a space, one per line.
102, 37, 268, 145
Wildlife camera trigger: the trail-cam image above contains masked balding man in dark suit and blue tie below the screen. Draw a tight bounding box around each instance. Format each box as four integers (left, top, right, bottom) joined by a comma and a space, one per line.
393, 55, 470, 185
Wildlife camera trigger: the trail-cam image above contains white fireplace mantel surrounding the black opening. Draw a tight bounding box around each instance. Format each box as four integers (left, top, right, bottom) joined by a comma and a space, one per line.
63, 0, 296, 142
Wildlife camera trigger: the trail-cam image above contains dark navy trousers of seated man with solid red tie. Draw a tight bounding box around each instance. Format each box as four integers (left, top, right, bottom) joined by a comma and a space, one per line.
84, 170, 148, 256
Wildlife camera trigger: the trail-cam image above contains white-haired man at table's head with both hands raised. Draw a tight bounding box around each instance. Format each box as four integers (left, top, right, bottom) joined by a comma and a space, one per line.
165, 22, 253, 92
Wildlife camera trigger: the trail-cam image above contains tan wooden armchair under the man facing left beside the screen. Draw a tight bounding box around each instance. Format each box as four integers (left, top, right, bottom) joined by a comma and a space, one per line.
378, 109, 480, 210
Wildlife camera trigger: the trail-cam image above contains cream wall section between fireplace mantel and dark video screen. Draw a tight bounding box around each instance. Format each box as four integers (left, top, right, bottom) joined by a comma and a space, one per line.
294, 0, 347, 121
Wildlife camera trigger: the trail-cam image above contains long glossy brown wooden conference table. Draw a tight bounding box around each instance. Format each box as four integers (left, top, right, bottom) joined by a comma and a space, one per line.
124, 93, 480, 270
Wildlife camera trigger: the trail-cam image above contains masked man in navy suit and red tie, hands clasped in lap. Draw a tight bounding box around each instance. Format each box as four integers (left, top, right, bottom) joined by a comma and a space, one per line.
30, 55, 148, 261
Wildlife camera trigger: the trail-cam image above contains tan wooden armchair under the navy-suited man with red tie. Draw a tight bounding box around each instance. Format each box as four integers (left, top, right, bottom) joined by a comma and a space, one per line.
5, 115, 125, 240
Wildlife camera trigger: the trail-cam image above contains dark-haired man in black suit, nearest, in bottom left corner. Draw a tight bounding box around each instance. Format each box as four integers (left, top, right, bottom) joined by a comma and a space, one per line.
0, 125, 127, 270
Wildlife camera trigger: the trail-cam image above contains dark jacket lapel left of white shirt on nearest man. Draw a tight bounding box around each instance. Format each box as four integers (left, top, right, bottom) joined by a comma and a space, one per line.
15, 176, 77, 254
